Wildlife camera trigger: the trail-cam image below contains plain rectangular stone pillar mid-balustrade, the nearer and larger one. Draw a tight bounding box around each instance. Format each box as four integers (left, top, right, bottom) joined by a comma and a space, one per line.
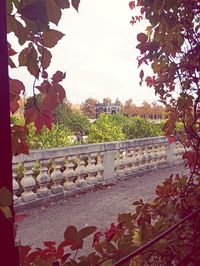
103, 151, 115, 180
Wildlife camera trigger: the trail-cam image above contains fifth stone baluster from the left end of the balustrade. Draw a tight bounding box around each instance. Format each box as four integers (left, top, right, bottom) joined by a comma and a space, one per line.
63, 156, 77, 191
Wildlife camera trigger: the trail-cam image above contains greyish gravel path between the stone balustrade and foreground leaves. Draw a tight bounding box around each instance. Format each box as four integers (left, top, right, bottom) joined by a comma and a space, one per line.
17, 166, 184, 247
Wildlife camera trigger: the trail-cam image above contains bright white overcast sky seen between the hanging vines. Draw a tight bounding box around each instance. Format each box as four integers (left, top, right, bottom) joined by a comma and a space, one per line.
11, 0, 159, 105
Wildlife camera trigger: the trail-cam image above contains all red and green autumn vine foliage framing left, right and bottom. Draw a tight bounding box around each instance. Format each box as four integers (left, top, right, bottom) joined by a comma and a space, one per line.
3, 0, 200, 266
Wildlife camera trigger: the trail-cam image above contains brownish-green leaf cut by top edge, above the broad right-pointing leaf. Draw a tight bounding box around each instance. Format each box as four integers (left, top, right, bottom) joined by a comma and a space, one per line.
46, 0, 62, 25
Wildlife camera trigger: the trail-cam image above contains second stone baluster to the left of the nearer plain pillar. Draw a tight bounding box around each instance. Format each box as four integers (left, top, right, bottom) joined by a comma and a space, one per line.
86, 153, 98, 185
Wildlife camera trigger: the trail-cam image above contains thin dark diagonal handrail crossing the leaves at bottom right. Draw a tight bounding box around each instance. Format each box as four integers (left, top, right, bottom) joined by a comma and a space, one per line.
113, 208, 200, 266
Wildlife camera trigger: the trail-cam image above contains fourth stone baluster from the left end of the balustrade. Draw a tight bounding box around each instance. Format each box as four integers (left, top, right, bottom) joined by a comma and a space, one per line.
50, 158, 63, 194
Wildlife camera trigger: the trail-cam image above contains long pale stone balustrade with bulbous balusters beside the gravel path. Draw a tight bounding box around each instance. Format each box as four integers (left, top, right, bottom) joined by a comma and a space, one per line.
13, 137, 183, 210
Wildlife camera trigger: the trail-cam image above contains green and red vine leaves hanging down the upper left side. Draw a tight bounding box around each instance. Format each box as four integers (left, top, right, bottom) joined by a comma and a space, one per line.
6, 0, 80, 155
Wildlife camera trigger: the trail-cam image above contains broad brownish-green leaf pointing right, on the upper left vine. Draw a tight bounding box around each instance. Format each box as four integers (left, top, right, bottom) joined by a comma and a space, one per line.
43, 30, 64, 48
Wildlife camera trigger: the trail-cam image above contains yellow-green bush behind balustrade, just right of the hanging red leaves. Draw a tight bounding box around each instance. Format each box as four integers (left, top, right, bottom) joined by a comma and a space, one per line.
28, 124, 71, 149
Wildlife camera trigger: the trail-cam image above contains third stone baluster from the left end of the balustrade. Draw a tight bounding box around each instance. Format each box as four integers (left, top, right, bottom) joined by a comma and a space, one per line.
36, 160, 51, 198
